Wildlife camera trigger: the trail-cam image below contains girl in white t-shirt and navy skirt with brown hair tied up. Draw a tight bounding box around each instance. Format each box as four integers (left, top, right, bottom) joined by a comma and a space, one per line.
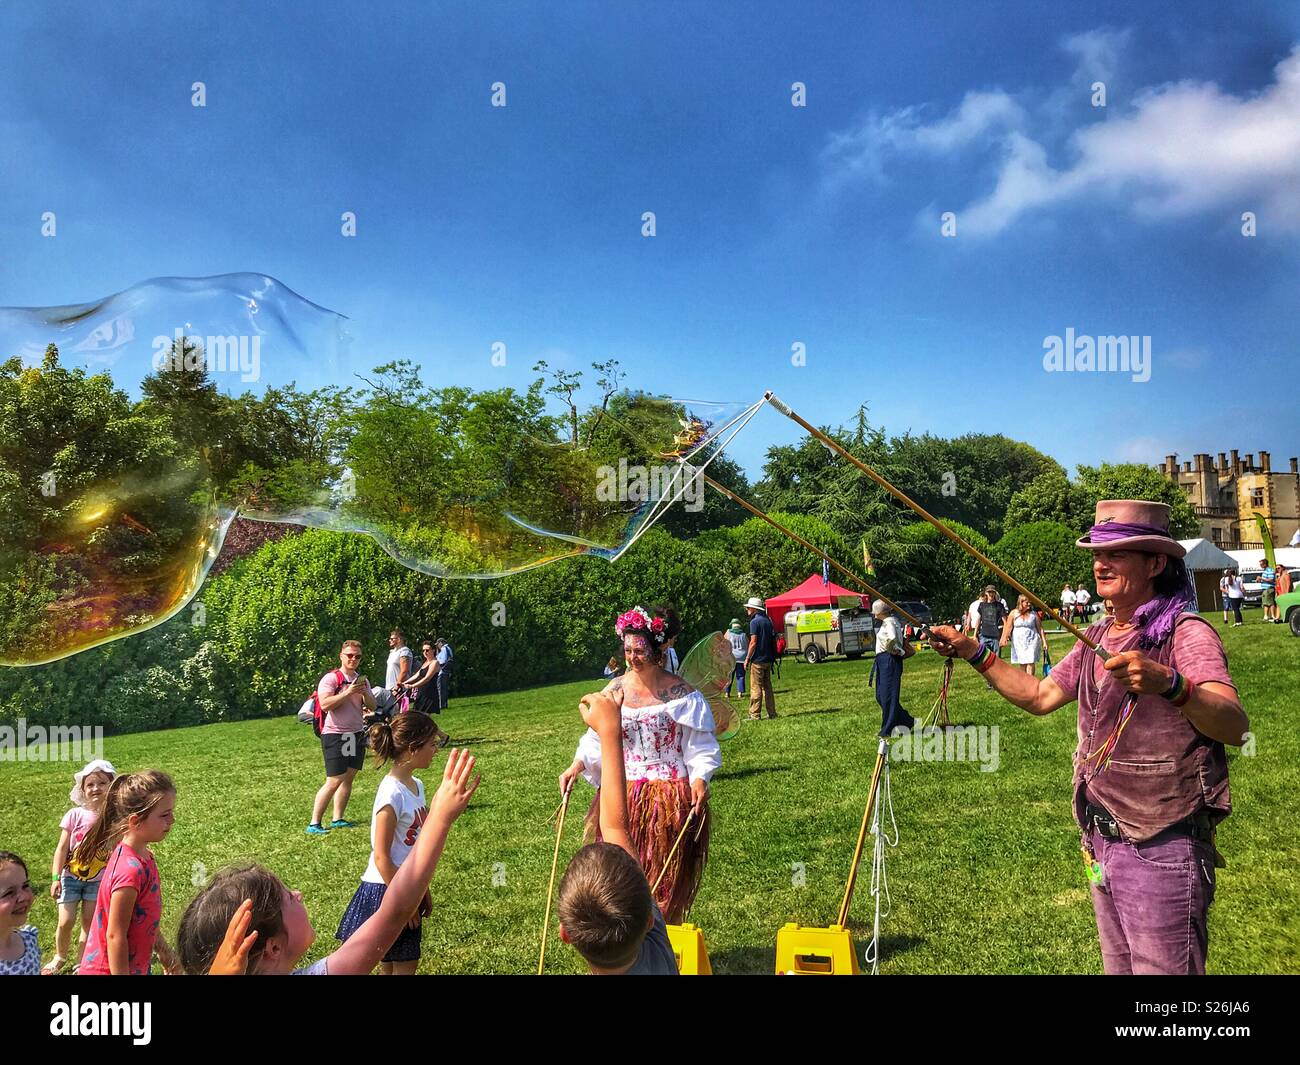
334, 710, 438, 977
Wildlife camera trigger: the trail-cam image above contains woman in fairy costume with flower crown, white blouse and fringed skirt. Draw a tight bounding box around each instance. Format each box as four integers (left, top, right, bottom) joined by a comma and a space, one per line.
560, 606, 722, 925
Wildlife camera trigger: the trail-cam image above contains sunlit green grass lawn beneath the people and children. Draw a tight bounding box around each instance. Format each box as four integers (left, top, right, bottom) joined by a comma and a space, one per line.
0, 611, 1300, 973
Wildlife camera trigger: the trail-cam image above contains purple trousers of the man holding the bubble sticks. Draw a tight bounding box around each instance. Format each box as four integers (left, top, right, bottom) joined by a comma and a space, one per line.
1084, 827, 1214, 977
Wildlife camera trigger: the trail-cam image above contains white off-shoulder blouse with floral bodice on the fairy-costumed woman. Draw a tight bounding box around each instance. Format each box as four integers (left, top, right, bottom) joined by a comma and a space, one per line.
573, 692, 723, 788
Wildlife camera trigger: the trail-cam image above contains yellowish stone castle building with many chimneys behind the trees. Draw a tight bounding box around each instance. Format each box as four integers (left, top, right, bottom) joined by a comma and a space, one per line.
1160, 451, 1300, 551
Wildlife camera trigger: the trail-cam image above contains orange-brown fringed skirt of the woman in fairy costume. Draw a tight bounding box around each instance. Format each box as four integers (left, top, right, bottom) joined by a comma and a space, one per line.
585, 780, 712, 925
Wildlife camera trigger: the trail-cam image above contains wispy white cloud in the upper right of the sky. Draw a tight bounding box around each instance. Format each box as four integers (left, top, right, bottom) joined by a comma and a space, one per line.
823, 30, 1300, 237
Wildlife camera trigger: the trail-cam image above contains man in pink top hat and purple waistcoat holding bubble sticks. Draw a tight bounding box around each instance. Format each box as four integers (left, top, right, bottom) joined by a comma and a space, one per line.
931, 499, 1249, 974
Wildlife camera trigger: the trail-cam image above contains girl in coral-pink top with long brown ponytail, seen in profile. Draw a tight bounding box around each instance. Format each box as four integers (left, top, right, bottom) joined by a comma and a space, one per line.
73, 770, 179, 977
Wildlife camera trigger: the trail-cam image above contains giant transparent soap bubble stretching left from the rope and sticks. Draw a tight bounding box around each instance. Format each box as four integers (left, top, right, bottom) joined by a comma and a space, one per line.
0, 273, 757, 664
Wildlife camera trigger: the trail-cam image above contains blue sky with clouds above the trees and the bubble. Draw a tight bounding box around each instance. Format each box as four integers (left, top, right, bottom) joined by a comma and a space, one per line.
0, 0, 1300, 473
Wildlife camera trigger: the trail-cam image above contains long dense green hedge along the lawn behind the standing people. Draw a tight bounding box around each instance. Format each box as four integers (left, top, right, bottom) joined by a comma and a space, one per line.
0, 529, 740, 732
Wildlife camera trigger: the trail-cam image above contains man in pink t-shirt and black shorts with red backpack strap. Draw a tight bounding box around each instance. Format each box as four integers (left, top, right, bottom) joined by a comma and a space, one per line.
307, 640, 374, 836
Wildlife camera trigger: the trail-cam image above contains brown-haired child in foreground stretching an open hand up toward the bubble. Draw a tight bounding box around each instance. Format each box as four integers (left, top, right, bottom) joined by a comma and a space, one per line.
177, 750, 478, 977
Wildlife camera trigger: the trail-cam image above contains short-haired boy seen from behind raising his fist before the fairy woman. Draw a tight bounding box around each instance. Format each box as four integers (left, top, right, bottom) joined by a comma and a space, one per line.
558, 693, 677, 977
